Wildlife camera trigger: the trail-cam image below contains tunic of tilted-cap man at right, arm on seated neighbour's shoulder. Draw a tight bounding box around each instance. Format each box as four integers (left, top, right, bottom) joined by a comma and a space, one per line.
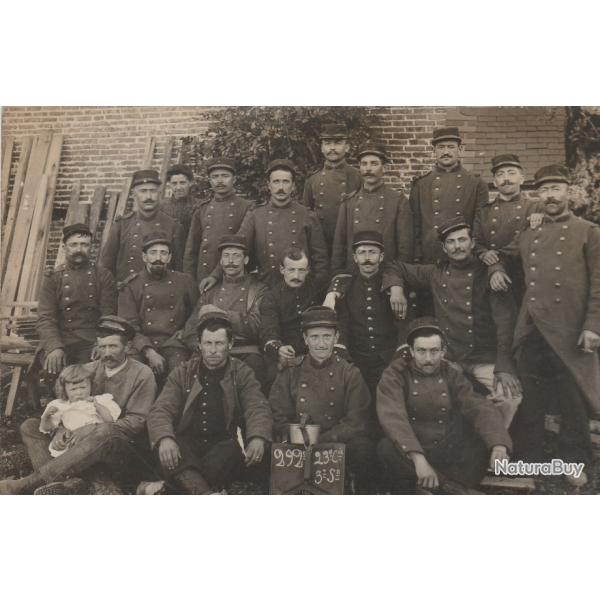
383, 256, 516, 373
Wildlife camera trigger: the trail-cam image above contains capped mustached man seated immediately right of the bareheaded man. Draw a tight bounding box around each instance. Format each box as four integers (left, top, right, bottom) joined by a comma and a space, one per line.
336, 231, 406, 406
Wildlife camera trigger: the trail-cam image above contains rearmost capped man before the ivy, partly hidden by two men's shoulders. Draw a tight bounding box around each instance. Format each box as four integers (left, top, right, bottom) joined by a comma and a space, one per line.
302, 123, 361, 256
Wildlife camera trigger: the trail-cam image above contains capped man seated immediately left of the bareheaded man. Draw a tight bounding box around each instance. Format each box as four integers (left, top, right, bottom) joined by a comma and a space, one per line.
183, 235, 267, 387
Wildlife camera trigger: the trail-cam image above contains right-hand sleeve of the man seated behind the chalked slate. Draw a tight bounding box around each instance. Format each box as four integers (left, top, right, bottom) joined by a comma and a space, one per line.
319, 365, 371, 443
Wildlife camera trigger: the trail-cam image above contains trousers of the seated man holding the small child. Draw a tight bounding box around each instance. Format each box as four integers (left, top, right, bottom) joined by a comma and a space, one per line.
20, 418, 153, 490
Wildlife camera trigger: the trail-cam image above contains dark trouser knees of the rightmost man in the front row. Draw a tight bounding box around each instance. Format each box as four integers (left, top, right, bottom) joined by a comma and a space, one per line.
377, 435, 489, 494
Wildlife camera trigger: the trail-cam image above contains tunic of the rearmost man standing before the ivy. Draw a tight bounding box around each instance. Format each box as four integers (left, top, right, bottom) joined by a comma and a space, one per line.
302, 161, 361, 256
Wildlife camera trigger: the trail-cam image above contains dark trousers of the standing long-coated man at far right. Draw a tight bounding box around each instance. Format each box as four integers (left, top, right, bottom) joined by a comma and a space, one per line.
511, 328, 592, 463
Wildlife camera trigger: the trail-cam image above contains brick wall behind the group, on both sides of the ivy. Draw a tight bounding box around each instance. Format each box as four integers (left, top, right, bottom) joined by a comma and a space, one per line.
2, 107, 565, 270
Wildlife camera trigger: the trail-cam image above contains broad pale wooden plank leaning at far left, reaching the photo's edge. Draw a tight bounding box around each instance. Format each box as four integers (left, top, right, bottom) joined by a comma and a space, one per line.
0, 132, 51, 315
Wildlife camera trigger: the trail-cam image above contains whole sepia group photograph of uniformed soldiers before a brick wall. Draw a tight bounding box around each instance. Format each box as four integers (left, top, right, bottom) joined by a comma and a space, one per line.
0, 106, 600, 495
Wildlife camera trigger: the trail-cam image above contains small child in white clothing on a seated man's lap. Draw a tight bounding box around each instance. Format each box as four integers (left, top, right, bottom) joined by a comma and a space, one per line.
40, 365, 121, 457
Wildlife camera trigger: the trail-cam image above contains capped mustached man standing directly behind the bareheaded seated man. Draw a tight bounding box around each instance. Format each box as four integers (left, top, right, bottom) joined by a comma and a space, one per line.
200, 159, 329, 291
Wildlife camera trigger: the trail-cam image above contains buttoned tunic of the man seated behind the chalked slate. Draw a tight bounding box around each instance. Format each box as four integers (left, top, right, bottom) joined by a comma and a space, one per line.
269, 355, 371, 443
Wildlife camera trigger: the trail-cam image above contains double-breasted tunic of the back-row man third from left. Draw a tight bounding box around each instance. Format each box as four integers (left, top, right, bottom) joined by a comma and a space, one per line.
183, 192, 252, 281
